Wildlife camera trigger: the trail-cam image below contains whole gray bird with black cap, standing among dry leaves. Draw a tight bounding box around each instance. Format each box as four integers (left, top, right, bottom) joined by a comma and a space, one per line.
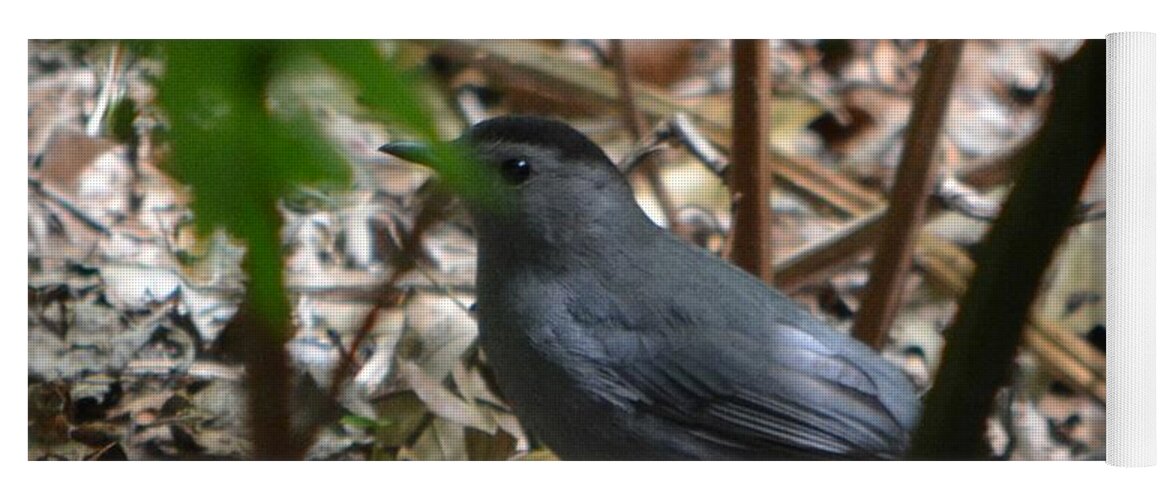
379, 117, 919, 460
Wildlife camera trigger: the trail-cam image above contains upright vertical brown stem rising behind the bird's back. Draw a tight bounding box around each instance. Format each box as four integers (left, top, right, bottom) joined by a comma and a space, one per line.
728, 40, 773, 281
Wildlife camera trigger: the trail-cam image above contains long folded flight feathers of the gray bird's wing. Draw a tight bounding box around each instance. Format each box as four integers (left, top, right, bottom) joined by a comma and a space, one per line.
609, 324, 918, 459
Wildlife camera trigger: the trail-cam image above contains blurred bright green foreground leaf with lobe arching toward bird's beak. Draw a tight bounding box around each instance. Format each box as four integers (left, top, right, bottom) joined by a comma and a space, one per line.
151, 40, 452, 330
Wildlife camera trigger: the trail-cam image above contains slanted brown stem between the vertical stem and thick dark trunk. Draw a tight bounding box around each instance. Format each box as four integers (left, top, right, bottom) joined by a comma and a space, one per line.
854, 40, 964, 349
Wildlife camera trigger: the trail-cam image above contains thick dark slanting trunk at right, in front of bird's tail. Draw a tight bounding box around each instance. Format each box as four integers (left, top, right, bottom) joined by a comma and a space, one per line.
911, 40, 1105, 459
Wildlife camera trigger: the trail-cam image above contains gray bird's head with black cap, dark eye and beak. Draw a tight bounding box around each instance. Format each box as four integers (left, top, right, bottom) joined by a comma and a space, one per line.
378, 116, 638, 243
